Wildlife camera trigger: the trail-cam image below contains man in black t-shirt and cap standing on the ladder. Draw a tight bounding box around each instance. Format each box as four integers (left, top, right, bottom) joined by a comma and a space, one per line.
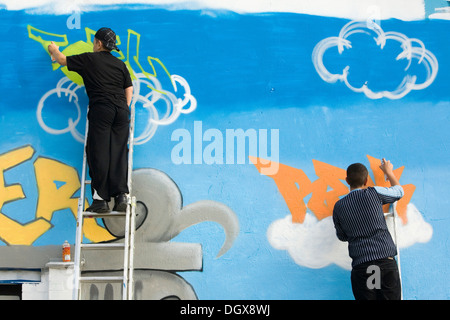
48, 28, 133, 213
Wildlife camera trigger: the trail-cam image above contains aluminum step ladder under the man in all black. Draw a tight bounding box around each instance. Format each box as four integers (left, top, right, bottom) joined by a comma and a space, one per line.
73, 104, 136, 300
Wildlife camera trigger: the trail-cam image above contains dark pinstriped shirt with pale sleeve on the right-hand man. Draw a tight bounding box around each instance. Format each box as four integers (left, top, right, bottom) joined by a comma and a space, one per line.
333, 185, 404, 267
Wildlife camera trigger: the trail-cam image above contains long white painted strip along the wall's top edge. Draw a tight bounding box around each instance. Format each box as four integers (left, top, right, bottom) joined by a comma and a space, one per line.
0, 0, 425, 20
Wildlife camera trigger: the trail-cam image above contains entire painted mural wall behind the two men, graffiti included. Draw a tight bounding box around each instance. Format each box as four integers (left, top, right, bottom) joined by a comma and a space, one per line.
0, 0, 450, 299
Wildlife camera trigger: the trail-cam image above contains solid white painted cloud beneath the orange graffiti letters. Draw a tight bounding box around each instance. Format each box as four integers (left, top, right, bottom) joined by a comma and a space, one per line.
267, 203, 433, 270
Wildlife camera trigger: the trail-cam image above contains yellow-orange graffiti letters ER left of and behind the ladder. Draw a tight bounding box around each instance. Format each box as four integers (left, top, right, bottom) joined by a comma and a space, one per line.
0, 146, 112, 245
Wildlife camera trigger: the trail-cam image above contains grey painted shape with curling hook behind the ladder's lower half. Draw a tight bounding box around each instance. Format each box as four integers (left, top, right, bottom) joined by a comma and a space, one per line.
82, 169, 239, 299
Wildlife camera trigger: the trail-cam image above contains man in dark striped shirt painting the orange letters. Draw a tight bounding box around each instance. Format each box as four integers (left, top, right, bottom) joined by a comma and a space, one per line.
333, 158, 404, 300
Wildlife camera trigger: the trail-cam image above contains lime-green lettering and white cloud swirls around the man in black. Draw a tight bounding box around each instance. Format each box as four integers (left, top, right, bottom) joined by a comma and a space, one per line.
27, 25, 197, 144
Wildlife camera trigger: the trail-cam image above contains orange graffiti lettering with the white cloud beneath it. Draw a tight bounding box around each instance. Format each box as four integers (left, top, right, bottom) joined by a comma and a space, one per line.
252, 156, 433, 270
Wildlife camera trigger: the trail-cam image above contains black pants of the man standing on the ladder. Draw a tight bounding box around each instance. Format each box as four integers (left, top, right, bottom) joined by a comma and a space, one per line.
86, 104, 130, 201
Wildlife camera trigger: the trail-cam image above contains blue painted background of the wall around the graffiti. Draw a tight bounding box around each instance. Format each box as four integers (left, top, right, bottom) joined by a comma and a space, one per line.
0, 6, 450, 299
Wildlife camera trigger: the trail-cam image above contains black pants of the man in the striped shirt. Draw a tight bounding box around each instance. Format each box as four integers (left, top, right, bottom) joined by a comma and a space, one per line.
351, 258, 401, 300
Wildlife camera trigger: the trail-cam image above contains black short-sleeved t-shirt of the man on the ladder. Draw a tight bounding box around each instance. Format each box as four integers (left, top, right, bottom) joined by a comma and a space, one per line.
67, 51, 132, 108
